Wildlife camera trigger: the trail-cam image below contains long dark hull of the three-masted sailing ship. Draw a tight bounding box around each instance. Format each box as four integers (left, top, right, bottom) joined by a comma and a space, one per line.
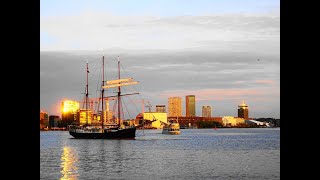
69, 128, 136, 139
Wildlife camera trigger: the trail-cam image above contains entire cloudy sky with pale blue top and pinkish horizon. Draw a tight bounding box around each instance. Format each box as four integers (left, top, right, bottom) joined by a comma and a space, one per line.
40, 0, 280, 118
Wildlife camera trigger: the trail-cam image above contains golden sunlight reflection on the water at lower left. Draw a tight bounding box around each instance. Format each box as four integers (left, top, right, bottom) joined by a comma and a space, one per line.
60, 147, 79, 180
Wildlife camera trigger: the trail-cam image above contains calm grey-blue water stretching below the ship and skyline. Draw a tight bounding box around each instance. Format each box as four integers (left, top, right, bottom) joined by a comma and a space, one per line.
40, 128, 280, 179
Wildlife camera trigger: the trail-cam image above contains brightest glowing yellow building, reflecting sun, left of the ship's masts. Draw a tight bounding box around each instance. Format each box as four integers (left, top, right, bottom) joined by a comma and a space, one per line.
61, 100, 80, 126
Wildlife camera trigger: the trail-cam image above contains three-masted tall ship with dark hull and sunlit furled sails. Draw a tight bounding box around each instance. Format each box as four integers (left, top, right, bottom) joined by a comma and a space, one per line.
68, 56, 139, 139
